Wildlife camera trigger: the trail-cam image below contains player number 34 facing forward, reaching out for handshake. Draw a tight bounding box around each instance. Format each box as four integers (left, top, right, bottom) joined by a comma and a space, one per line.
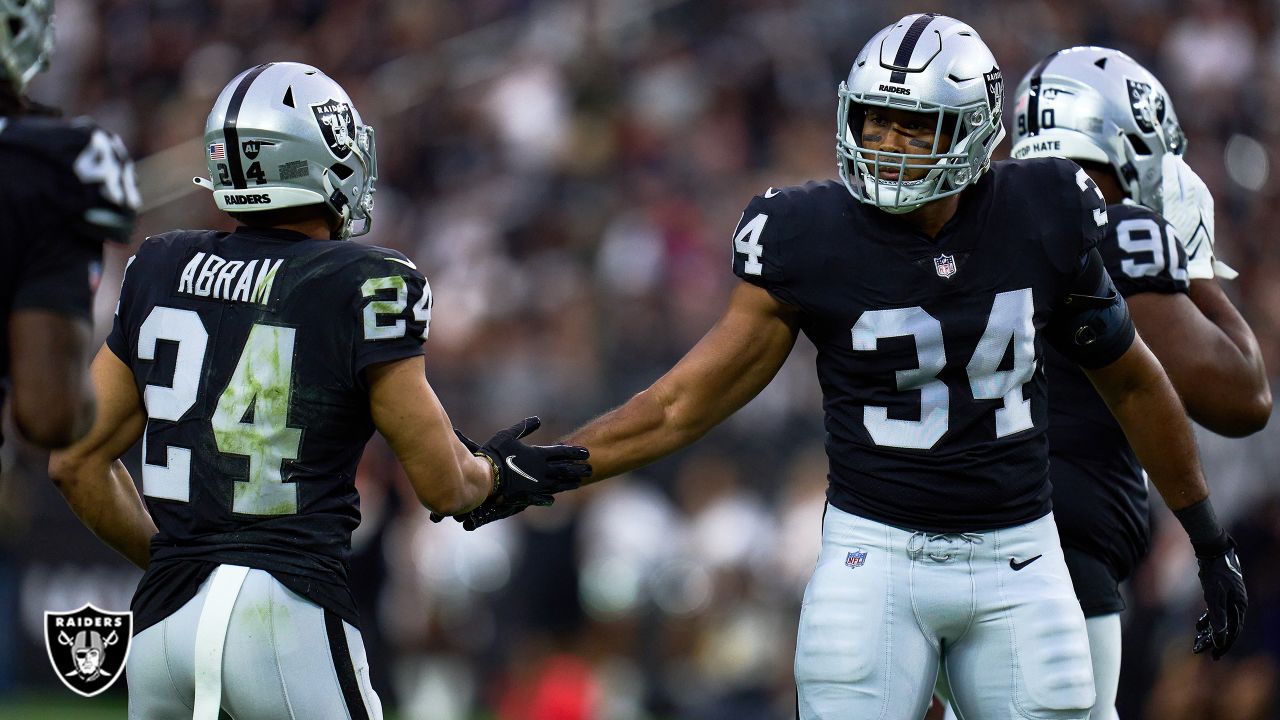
442, 13, 1245, 720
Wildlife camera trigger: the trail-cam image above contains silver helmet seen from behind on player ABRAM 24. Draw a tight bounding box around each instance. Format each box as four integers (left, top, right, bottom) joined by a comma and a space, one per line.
195, 63, 378, 240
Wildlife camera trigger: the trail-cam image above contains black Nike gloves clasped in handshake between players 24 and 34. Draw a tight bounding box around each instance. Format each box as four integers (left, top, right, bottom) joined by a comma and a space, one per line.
431, 416, 591, 530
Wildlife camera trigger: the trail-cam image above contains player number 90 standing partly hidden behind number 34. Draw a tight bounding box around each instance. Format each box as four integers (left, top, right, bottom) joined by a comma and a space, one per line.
942, 47, 1271, 720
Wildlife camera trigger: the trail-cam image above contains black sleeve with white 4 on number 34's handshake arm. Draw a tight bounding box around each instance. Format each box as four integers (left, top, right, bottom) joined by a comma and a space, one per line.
733, 187, 805, 305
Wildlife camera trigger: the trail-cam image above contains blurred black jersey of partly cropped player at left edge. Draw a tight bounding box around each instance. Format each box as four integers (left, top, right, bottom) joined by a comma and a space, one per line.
0, 117, 138, 392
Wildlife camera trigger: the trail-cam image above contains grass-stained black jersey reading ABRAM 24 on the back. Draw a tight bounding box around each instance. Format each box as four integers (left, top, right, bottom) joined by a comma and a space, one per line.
108, 228, 431, 629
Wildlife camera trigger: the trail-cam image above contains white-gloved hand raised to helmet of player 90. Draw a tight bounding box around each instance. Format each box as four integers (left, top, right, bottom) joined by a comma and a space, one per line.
1160, 152, 1238, 281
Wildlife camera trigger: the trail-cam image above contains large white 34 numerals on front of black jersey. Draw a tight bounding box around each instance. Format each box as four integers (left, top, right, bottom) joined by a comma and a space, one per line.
852, 288, 1036, 450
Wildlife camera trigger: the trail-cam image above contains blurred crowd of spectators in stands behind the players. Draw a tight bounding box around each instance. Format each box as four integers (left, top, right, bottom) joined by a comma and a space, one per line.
0, 0, 1280, 720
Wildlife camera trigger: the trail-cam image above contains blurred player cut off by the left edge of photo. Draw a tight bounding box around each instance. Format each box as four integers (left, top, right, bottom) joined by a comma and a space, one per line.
0, 0, 138, 447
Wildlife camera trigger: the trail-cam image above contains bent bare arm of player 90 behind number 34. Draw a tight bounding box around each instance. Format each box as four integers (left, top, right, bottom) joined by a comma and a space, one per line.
1129, 278, 1271, 437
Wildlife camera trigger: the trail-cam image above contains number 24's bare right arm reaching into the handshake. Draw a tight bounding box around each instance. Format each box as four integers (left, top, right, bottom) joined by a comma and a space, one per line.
365, 356, 495, 515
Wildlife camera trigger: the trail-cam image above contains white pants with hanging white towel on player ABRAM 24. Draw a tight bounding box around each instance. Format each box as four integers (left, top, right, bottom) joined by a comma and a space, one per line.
127, 565, 383, 720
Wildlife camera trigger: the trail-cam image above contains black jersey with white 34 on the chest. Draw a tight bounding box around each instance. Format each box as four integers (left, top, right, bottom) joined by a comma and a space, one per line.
733, 159, 1132, 532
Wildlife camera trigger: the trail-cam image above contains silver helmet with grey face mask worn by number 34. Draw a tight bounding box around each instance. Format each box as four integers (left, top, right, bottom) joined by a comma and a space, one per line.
836, 13, 1005, 214
